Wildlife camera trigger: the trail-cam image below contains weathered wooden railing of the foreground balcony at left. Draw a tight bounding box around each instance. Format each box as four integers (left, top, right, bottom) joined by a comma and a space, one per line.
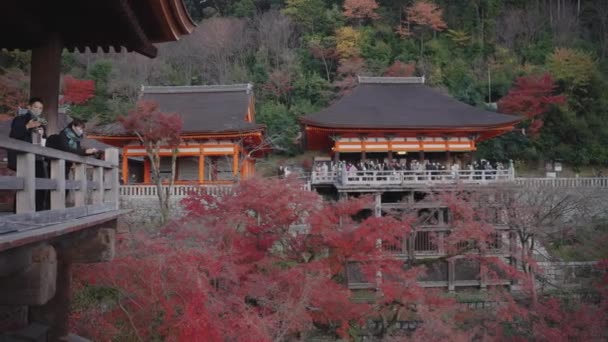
0, 137, 119, 233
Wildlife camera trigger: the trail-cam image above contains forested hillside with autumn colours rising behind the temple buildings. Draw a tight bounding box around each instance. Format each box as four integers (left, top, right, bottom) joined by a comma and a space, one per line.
0, 0, 608, 166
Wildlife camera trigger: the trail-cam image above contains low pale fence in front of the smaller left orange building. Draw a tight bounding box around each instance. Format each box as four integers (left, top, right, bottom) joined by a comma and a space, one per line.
120, 185, 233, 198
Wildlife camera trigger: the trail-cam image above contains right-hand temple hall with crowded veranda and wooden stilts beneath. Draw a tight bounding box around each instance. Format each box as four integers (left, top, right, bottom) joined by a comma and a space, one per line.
301, 77, 520, 291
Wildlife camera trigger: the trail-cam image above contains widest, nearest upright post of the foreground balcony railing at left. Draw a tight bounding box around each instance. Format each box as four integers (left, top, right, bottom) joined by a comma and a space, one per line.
15, 153, 36, 214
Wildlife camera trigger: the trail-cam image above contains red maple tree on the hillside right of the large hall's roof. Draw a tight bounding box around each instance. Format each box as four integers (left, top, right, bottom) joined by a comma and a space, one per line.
498, 74, 566, 135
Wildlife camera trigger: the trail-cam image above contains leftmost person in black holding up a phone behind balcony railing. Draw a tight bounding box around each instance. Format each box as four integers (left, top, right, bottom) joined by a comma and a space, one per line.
7, 97, 48, 211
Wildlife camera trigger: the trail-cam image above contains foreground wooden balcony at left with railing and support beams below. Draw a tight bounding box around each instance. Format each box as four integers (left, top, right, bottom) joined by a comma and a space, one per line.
0, 137, 123, 341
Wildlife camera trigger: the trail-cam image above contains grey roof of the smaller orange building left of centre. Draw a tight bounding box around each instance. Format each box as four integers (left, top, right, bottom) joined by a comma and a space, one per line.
91, 84, 264, 136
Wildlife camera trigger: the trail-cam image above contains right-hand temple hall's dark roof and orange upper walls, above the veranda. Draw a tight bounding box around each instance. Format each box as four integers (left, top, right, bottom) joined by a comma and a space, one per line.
300, 77, 521, 164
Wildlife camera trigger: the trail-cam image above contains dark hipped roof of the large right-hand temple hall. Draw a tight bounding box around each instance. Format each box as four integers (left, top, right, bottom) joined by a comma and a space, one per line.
301, 77, 520, 129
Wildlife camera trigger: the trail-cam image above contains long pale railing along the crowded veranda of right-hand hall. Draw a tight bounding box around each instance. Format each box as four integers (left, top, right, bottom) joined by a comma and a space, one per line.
311, 168, 515, 186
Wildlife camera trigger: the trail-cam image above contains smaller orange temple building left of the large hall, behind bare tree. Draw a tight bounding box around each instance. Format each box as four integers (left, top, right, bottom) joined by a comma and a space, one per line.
89, 84, 266, 184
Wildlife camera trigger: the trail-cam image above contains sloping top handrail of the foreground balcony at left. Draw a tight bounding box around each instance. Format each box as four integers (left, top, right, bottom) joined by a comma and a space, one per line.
0, 137, 118, 168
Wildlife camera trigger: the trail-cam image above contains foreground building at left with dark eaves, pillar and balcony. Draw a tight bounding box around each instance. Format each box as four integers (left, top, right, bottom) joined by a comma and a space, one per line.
0, 0, 195, 341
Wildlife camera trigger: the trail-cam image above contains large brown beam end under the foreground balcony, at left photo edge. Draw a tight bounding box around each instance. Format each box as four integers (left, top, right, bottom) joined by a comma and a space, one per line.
0, 245, 57, 305
